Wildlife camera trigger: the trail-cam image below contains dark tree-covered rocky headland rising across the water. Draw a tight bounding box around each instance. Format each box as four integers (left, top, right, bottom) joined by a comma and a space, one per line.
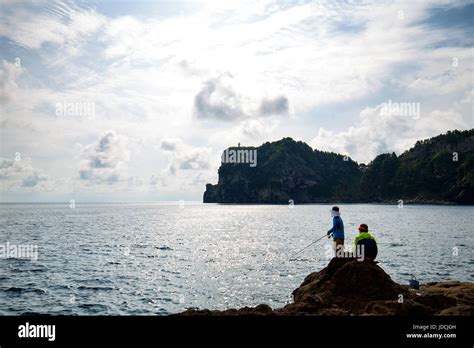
203, 129, 474, 204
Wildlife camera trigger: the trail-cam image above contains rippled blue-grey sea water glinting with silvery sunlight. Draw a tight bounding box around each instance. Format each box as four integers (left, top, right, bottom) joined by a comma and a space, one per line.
0, 203, 474, 315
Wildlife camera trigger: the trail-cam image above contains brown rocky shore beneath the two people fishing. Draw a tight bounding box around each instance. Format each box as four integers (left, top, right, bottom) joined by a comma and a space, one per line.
178, 258, 474, 316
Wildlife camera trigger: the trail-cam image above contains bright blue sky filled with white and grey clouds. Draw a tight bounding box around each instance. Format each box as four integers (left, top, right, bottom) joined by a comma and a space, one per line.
0, 0, 474, 202
